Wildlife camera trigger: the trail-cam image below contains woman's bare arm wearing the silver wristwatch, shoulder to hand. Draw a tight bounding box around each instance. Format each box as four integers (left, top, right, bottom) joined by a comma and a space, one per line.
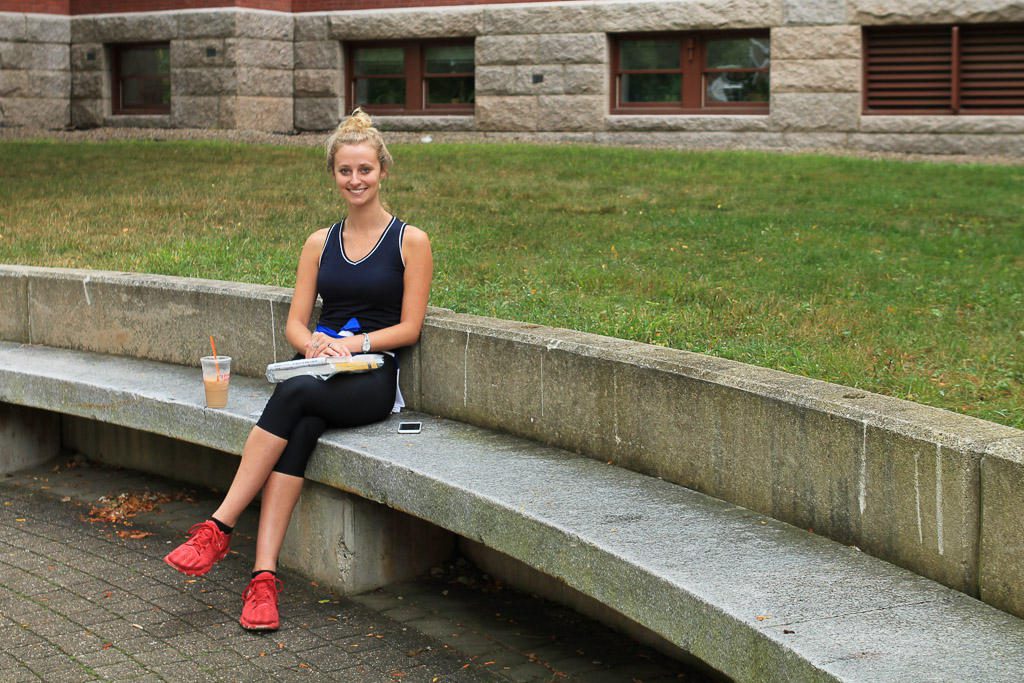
333, 225, 434, 353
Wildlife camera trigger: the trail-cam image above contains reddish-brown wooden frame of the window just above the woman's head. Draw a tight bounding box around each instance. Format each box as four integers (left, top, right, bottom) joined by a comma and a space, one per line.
345, 38, 476, 116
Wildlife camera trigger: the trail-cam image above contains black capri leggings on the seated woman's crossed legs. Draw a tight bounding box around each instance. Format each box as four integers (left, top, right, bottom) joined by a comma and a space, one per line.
256, 353, 397, 476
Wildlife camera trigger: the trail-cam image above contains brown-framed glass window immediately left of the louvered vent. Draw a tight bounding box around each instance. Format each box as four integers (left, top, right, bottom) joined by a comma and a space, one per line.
611, 32, 771, 114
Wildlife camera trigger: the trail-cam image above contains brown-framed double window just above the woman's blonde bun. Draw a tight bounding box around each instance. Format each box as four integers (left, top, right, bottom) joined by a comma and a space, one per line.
346, 41, 474, 115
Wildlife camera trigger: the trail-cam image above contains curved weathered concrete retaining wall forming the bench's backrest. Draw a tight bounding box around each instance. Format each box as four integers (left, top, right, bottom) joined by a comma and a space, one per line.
6, 266, 1024, 615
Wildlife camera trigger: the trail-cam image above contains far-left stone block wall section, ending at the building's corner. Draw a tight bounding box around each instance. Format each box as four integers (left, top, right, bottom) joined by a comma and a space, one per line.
0, 12, 72, 128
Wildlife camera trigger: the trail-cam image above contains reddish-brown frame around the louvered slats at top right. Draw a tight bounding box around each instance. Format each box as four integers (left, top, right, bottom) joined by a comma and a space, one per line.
861, 24, 1024, 116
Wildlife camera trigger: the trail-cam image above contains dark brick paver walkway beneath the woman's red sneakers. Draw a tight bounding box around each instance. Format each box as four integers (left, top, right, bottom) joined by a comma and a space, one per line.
0, 461, 705, 683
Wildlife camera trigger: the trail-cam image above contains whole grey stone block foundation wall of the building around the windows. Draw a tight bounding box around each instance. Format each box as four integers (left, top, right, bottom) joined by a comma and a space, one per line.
0, 0, 1024, 156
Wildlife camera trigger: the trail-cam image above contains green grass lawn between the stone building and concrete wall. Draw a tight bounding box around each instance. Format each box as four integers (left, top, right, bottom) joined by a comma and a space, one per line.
0, 141, 1024, 427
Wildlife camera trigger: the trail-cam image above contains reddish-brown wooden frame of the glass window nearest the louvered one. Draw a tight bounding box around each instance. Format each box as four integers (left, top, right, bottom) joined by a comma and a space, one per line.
609, 29, 771, 116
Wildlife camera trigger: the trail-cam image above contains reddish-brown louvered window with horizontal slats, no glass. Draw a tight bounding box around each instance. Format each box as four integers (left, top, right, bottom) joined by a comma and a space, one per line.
864, 24, 1024, 114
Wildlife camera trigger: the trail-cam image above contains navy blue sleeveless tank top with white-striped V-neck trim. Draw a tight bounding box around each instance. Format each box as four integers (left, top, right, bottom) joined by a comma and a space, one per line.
316, 217, 406, 332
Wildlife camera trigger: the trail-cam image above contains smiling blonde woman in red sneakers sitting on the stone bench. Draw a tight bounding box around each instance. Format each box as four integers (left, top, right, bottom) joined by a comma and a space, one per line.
165, 110, 433, 631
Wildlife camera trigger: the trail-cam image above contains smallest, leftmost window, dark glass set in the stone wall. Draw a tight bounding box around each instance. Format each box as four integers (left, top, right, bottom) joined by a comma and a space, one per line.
111, 43, 171, 114
